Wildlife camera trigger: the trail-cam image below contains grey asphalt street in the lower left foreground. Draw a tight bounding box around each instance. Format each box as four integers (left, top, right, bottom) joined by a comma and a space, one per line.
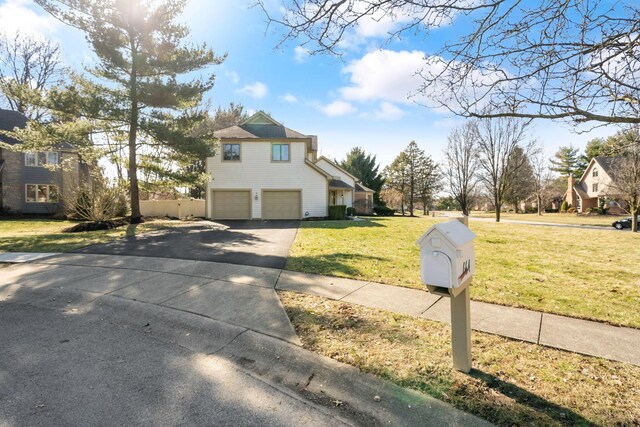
0, 302, 345, 426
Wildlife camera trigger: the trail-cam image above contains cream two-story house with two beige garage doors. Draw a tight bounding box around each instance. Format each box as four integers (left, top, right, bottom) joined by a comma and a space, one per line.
206, 111, 373, 219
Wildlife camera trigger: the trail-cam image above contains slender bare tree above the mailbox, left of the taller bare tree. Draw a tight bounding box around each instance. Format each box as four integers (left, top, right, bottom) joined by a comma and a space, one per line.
444, 121, 479, 216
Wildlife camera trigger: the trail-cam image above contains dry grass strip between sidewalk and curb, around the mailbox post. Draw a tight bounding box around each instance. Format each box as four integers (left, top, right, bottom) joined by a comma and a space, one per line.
279, 292, 640, 426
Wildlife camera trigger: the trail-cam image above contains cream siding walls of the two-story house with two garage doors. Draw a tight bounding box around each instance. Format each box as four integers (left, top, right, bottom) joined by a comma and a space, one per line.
207, 141, 328, 218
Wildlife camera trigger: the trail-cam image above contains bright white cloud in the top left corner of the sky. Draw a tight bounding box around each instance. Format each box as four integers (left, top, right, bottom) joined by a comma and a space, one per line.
0, 0, 60, 37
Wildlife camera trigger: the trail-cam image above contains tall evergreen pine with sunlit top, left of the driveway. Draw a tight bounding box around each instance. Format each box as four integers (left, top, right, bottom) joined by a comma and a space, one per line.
36, 0, 224, 223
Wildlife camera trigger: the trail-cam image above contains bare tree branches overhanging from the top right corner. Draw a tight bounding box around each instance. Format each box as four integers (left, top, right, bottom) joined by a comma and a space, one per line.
257, 0, 640, 124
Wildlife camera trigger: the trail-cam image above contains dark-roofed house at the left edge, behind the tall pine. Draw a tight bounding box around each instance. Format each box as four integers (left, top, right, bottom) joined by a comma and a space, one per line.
0, 109, 88, 214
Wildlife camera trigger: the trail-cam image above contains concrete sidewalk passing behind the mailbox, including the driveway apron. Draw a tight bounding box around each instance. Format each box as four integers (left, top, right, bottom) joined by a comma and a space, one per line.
0, 254, 640, 366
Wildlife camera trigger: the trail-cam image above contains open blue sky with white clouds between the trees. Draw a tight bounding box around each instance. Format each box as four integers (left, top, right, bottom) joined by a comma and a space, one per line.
0, 0, 615, 166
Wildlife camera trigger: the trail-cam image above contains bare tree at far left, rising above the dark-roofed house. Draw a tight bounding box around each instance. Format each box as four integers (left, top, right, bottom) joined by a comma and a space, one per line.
0, 33, 62, 120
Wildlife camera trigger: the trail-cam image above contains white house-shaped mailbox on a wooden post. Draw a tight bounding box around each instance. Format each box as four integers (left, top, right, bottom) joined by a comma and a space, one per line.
416, 220, 476, 372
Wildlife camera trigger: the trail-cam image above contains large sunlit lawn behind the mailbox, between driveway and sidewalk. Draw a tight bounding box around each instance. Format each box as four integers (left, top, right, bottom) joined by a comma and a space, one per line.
286, 217, 640, 328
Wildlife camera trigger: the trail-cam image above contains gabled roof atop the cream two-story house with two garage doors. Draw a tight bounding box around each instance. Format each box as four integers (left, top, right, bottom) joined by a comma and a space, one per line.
213, 111, 310, 144
